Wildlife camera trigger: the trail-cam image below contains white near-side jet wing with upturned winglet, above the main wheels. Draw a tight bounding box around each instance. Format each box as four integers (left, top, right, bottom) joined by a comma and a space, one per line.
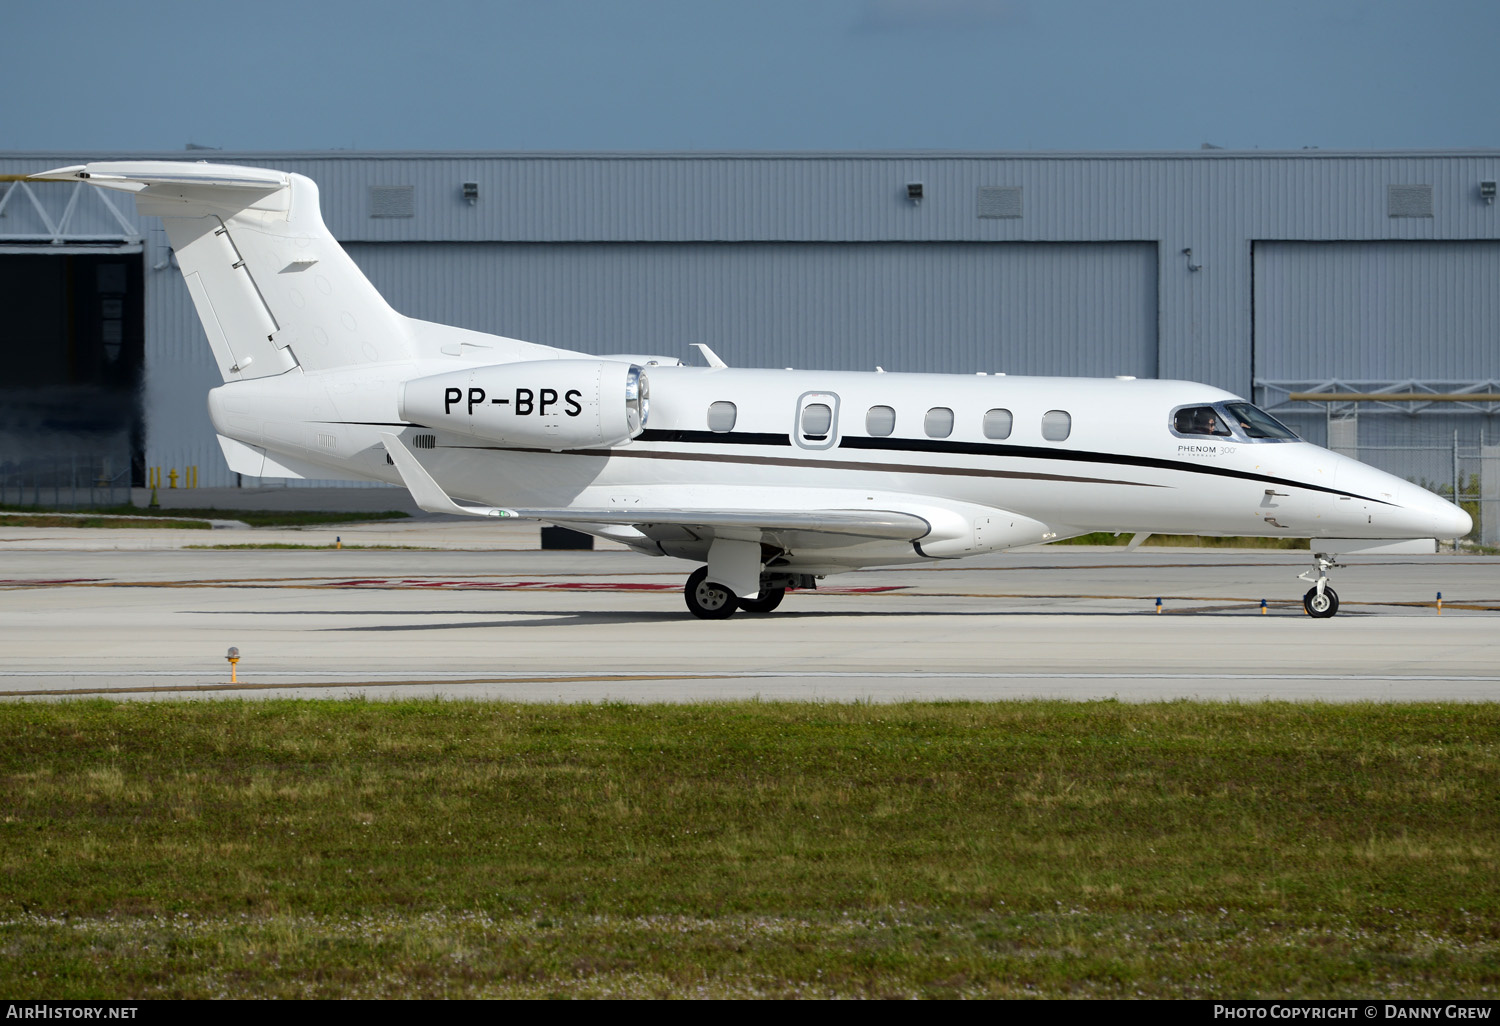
381, 432, 932, 542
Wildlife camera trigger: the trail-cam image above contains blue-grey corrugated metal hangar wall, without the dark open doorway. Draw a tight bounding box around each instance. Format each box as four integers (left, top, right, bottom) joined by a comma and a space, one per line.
0, 152, 1500, 483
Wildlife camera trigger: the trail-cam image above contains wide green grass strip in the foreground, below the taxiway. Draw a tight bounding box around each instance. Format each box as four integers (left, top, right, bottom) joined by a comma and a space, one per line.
0, 701, 1500, 999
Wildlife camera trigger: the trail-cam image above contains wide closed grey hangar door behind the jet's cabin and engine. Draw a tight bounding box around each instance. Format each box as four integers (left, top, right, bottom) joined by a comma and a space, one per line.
348, 242, 1158, 378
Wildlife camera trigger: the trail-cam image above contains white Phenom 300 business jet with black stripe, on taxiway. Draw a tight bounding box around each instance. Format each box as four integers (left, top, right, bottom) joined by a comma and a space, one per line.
35, 161, 1472, 620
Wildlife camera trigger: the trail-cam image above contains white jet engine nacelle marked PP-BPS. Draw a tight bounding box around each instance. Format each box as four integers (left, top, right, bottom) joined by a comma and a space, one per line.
398, 360, 651, 450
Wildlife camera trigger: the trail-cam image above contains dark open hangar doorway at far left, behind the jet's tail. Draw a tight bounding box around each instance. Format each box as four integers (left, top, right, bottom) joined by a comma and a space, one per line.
0, 252, 144, 506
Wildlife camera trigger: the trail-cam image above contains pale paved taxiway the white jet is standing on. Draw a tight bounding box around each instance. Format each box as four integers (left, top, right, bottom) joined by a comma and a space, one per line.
0, 521, 1500, 702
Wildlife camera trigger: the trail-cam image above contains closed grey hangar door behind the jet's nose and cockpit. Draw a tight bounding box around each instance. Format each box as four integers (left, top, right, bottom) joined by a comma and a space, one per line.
1254, 240, 1500, 495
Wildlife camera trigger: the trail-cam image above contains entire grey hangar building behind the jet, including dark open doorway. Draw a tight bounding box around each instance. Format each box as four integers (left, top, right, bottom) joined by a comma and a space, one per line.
0, 150, 1500, 528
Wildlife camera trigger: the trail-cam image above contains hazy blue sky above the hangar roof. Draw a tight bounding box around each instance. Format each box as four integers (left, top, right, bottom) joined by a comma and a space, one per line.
0, 0, 1500, 153
